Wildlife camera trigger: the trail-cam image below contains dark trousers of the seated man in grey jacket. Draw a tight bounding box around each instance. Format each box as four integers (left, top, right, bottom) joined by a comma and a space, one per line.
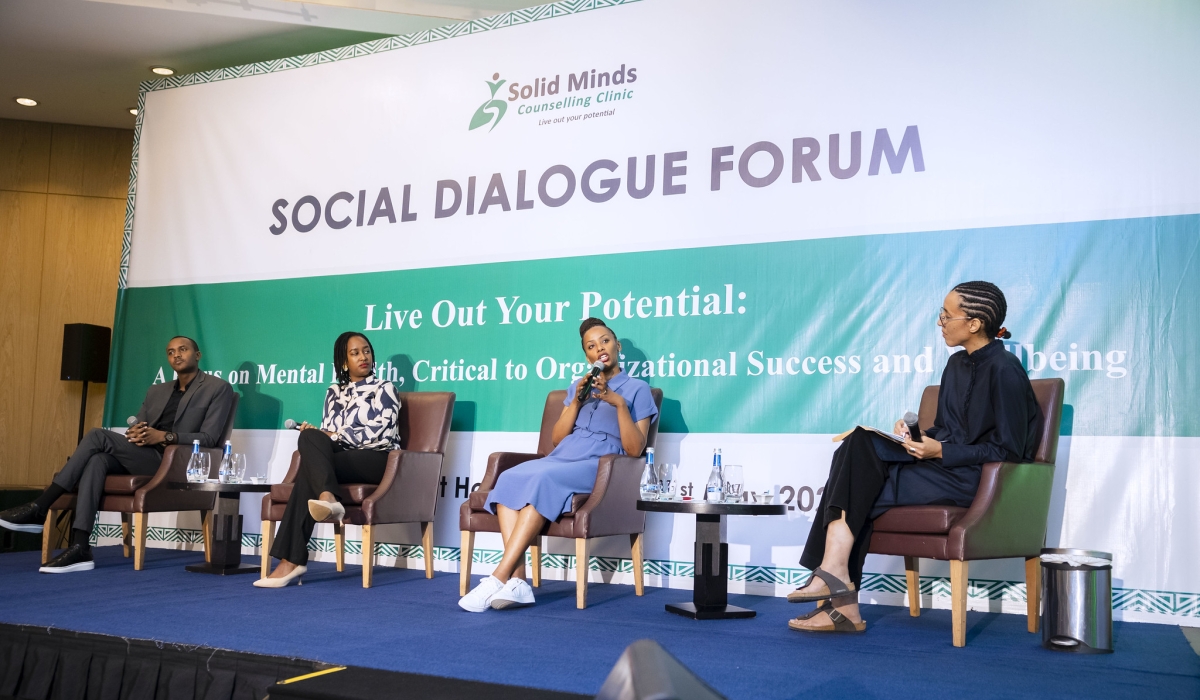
54, 427, 162, 532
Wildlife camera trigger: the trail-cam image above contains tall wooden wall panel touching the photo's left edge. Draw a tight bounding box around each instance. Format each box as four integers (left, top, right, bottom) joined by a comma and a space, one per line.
0, 192, 49, 485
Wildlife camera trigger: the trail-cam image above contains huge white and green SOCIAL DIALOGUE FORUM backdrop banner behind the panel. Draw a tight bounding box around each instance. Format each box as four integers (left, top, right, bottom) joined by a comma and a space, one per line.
97, 0, 1200, 623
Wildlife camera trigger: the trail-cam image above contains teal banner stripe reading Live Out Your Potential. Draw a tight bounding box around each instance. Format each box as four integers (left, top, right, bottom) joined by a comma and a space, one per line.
106, 215, 1200, 436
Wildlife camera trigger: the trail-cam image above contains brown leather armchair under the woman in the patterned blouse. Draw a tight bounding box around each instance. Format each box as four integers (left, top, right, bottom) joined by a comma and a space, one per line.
262, 391, 455, 588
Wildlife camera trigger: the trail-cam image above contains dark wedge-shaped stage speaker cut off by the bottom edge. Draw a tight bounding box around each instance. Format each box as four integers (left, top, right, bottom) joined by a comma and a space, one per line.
596, 639, 725, 700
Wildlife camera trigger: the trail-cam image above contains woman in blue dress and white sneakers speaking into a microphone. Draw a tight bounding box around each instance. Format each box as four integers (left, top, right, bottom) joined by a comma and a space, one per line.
458, 318, 659, 612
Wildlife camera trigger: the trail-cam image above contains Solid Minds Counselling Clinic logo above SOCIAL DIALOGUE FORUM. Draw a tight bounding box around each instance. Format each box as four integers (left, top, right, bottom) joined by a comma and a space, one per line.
467, 64, 637, 132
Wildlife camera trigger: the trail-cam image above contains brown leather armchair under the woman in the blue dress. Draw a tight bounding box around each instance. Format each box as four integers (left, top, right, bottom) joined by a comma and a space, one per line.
458, 389, 662, 610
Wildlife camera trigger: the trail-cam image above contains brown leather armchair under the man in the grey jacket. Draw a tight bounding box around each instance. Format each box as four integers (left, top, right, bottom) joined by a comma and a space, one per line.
42, 393, 239, 572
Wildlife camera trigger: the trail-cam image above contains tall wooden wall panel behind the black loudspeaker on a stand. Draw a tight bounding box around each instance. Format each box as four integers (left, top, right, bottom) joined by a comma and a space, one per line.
29, 194, 125, 484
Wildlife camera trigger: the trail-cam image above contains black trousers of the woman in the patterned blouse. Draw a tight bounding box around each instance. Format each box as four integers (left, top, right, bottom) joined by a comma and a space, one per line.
271, 430, 388, 566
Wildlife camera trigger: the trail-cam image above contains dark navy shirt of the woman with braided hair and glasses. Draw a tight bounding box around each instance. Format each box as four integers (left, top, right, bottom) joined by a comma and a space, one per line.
925, 341, 1042, 467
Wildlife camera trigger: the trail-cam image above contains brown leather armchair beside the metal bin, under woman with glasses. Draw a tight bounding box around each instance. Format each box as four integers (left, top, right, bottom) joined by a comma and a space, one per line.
870, 379, 1066, 646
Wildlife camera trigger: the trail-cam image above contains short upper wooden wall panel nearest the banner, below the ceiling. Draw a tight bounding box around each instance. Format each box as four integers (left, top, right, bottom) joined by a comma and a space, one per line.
47, 124, 133, 198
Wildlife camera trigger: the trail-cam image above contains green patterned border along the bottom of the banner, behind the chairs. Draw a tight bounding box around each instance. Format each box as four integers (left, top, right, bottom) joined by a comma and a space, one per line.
91, 523, 1200, 617
